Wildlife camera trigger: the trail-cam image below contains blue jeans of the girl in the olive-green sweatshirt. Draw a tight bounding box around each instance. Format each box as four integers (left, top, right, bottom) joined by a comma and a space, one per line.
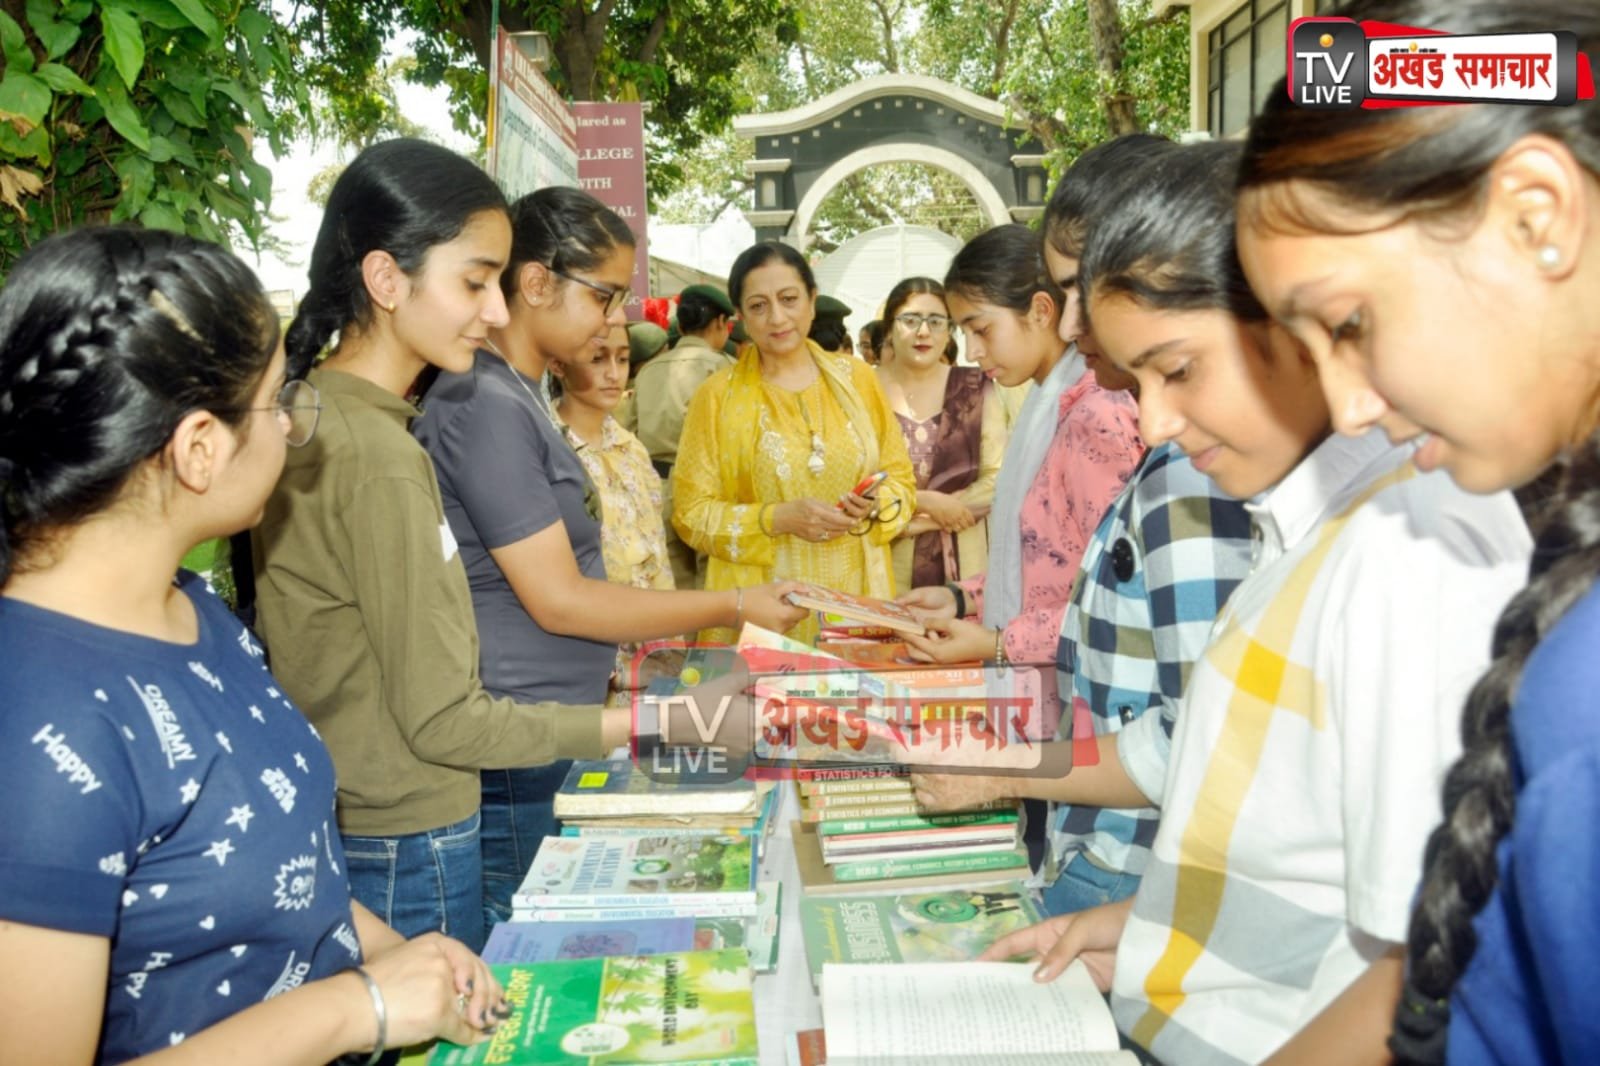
344, 815, 483, 951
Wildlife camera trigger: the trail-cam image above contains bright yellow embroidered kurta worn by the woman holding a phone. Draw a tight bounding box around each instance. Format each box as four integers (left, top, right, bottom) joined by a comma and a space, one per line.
672, 343, 917, 640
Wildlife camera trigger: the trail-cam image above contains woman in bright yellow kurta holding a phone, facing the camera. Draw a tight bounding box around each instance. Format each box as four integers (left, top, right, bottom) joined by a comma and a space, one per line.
672, 242, 917, 640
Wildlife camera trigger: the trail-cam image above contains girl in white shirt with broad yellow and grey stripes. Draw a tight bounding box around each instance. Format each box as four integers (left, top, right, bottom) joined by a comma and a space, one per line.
990, 144, 1528, 1064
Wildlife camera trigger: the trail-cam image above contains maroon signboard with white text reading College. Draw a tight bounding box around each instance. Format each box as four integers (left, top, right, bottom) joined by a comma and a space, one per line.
573, 101, 650, 322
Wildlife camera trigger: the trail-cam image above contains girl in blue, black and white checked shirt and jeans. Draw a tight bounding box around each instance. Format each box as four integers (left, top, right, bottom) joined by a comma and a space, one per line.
915, 134, 1251, 914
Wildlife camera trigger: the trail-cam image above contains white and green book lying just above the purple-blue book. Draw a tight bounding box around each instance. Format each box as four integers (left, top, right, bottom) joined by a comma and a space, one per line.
512, 832, 755, 909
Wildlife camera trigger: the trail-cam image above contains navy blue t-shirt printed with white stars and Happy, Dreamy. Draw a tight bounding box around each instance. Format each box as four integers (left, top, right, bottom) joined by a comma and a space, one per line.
0, 573, 360, 1063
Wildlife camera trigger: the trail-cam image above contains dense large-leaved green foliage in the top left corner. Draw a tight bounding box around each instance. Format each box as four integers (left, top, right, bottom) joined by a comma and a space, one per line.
0, 0, 309, 277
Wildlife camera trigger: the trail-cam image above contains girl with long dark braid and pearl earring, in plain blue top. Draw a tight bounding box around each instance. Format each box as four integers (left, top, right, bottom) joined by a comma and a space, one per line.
1240, 0, 1600, 1064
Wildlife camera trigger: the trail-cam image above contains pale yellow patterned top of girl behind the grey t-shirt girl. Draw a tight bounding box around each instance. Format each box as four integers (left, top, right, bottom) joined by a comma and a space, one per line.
557, 415, 674, 682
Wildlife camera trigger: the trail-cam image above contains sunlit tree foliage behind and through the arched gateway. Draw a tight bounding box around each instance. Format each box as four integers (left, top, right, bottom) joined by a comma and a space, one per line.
654, 0, 1189, 251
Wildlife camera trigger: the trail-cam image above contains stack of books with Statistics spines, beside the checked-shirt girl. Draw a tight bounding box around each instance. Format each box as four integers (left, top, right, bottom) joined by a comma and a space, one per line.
795, 767, 1027, 892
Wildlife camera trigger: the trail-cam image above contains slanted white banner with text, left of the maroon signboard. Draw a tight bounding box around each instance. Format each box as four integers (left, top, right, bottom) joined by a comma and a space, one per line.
488, 27, 578, 200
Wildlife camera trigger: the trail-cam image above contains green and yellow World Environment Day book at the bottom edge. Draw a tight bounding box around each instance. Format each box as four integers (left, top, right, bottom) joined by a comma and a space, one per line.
429, 951, 757, 1066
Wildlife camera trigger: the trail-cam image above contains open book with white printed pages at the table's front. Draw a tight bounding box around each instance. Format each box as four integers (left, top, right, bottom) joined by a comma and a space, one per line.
822, 962, 1139, 1066
